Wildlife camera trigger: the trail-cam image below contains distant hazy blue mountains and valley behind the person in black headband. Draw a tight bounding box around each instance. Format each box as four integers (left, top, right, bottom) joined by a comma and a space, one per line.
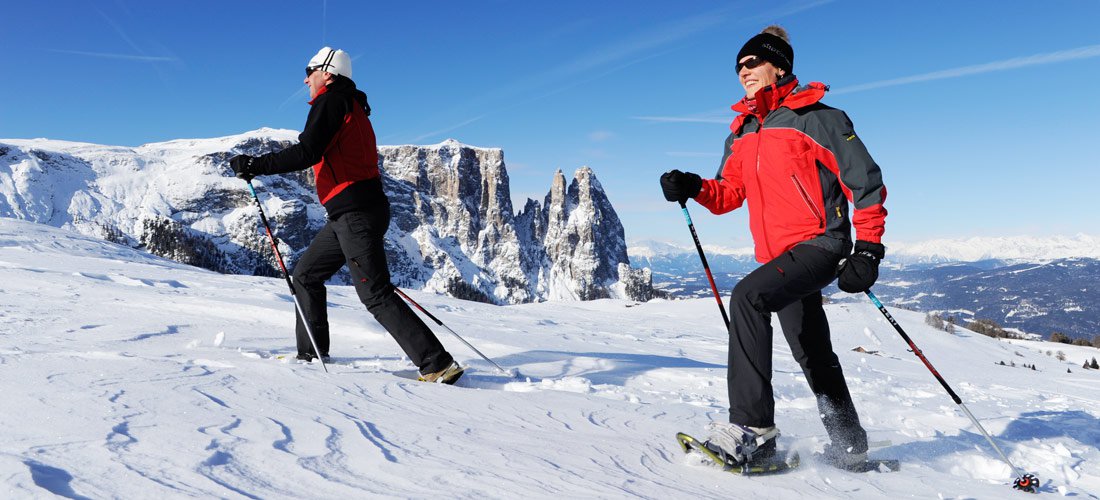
628, 240, 1100, 341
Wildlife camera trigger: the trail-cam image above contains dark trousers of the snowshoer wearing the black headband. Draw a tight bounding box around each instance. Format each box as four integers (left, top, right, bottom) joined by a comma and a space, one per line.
727, 244, 867, 452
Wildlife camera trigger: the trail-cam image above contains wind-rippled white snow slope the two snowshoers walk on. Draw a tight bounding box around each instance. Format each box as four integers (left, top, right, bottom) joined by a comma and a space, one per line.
0, 219, 1100, 499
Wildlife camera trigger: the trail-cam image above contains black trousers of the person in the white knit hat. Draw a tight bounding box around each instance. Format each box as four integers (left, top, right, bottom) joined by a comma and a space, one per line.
294, 203, 453, 374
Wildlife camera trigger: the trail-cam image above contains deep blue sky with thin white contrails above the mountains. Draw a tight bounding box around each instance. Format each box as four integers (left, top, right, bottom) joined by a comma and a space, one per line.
0, 0, 1100, 246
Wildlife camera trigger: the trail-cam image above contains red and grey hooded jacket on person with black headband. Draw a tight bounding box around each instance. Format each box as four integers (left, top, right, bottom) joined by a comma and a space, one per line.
695, 75, 887, 263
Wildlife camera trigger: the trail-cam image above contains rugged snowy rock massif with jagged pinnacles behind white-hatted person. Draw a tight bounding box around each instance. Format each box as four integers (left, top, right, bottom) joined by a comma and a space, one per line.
0, 129, 652, 303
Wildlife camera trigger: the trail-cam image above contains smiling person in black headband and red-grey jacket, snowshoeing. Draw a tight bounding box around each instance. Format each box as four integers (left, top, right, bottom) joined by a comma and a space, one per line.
661, 26, 887, 467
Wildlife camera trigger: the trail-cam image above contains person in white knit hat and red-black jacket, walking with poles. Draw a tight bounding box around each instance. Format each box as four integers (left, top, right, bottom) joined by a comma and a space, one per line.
230, 47, 462, 382
